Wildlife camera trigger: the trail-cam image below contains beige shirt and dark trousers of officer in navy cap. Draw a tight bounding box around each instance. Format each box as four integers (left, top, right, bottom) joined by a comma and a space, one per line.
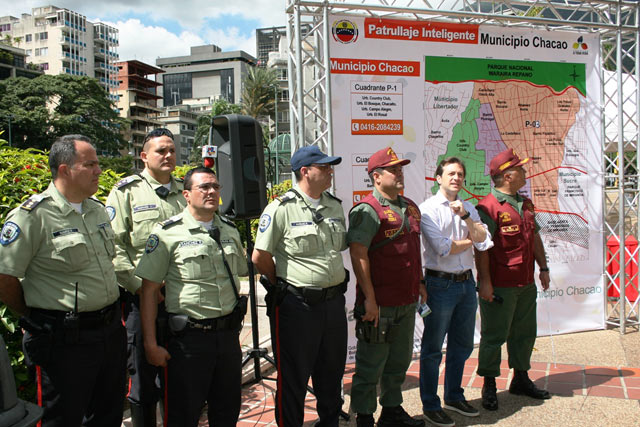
255, 187, 347, 426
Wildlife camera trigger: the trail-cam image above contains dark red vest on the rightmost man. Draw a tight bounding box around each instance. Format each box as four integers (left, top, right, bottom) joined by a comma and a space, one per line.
478, 194, 535, 288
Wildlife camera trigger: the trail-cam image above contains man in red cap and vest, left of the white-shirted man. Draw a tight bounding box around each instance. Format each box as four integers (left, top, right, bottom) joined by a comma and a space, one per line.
347, 147, 427, 427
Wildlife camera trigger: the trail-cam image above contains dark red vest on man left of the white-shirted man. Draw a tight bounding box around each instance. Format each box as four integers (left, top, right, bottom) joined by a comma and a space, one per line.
356, 194, 422, 307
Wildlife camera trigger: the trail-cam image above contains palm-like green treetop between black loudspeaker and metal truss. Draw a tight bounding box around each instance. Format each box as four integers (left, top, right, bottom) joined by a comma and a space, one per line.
242, 67, 277, 119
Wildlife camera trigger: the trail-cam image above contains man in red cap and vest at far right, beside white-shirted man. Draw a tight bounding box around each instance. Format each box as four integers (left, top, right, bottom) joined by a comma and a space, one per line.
475, 149, 551, 411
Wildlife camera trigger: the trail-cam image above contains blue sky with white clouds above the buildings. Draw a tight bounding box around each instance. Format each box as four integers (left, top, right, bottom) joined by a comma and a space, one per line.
0, 0, 286, 65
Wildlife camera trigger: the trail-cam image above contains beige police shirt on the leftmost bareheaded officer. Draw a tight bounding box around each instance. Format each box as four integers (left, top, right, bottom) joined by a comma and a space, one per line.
0, 183, 119, 312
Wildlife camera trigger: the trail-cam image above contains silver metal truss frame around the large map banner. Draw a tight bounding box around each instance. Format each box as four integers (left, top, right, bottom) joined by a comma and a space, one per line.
286, 0, 640, 334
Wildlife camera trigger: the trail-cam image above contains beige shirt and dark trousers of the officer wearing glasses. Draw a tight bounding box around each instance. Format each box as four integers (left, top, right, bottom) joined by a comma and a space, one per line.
136, 209, 247, 426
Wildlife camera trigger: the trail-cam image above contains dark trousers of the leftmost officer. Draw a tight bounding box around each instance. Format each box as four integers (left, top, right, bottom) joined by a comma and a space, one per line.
23, 310, 126, 427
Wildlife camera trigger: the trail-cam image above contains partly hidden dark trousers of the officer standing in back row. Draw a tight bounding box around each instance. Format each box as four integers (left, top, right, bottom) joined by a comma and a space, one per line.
123, 293, 166, 405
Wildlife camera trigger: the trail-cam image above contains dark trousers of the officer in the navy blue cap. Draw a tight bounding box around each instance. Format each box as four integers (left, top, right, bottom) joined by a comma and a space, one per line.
270, 293, 347, 427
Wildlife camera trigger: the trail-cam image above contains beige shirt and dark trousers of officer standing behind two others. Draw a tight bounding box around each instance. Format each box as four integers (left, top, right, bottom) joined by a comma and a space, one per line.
107, 170, 186, 412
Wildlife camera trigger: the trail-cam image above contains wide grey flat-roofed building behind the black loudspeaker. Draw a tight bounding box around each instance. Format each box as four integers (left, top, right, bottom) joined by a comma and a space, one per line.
156, 44, 256, 106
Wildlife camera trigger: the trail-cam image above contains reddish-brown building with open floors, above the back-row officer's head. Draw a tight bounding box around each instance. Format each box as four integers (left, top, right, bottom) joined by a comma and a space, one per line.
115, 60, 164, 170
